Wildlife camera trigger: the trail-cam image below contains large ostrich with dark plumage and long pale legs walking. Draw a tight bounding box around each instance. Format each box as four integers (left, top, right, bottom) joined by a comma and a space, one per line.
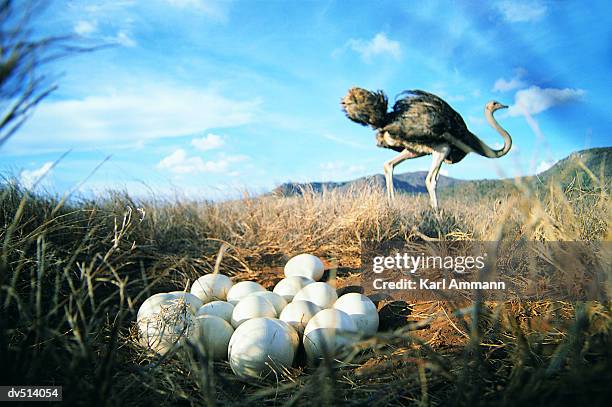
341, 88, 512, 209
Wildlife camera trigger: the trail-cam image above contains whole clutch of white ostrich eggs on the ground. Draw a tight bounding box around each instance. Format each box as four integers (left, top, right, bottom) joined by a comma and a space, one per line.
137, 254, 379, 378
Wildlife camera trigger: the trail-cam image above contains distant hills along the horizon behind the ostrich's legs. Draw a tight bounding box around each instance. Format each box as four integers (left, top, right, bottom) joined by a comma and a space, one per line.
272, 147, 612, 196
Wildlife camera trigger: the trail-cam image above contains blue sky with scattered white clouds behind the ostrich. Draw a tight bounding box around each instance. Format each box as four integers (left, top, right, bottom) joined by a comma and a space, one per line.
0, 0, 612, 199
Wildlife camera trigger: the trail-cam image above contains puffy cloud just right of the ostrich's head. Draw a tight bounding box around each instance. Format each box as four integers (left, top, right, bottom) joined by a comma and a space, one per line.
508, 86, 585, 116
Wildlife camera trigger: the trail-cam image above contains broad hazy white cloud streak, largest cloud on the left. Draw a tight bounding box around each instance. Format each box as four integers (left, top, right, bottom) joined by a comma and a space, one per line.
15, 79, 260, 150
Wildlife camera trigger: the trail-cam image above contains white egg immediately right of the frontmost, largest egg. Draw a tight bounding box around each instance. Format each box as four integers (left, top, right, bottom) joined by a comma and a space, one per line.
303, 308, 357, 361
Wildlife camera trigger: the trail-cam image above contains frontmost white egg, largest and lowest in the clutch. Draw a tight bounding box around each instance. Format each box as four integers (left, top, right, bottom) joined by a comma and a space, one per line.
228, 318, 297, 378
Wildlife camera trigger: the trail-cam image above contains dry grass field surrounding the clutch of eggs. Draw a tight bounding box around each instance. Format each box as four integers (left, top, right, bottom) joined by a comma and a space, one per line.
0, 175, 612, 406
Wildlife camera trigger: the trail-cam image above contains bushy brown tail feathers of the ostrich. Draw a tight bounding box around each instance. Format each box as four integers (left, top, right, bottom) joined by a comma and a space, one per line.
340, 88, 387, 128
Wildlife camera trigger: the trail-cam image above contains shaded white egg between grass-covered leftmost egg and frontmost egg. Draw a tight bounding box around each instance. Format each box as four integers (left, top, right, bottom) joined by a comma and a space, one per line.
190, 315, 234, 360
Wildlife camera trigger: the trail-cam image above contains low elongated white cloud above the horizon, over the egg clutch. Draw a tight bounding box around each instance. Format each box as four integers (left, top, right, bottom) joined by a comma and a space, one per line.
157, 148, 248, 174
